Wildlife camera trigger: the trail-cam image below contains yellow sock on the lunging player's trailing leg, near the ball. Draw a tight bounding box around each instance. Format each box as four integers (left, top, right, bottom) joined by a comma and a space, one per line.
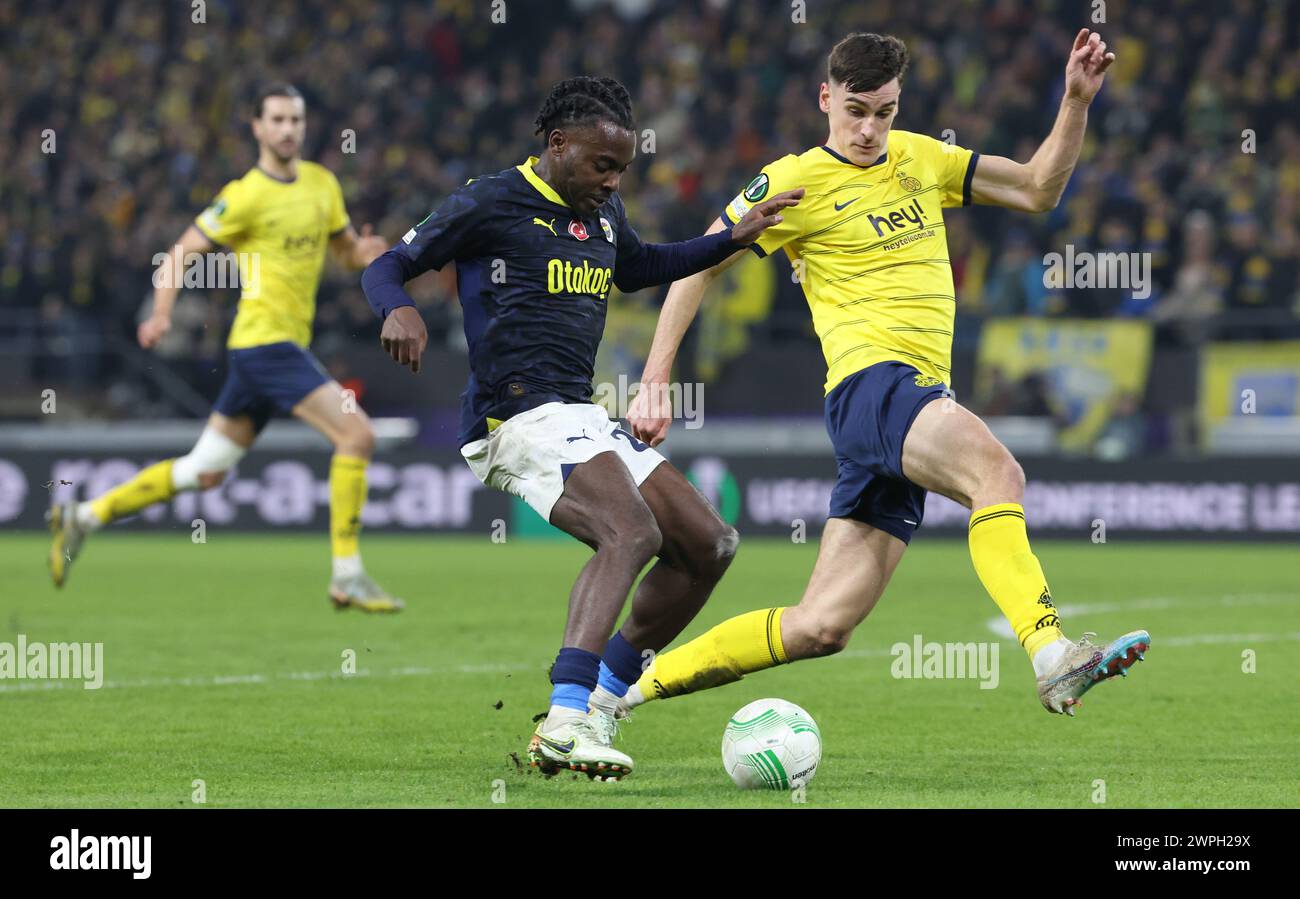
637, 607, 787, 700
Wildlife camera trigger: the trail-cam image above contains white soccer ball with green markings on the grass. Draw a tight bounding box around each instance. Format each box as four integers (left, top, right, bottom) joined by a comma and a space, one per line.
723, 699, 822, 790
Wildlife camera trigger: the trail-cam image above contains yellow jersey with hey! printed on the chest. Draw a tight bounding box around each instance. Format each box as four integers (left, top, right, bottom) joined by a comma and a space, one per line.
723, 130, 979, 394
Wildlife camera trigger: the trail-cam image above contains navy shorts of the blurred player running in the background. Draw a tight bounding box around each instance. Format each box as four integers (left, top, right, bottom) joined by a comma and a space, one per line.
212, 340, 332, 433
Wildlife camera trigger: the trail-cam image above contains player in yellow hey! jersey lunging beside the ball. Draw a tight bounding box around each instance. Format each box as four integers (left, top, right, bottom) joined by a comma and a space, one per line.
624, 29, 1151, 716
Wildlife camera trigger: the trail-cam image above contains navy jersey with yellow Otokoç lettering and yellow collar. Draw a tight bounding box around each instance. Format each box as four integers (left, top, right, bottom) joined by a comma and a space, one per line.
379, 157, 737, 444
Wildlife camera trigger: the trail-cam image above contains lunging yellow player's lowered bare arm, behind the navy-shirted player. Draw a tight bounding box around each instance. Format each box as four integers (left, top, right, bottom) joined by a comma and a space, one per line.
628, 217, 745, 447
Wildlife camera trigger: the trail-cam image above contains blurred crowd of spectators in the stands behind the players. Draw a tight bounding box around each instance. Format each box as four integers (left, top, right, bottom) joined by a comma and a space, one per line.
0, 0, 1300, 431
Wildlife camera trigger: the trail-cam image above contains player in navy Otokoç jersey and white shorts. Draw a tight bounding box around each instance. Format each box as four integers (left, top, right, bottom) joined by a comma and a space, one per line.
361, 77, 803, 779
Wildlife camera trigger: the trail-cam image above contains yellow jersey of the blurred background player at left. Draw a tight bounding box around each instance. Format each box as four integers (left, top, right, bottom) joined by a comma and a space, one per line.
194, 161, 348, 349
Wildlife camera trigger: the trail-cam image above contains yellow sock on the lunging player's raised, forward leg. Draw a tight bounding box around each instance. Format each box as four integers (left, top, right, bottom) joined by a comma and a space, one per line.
970, 503, 1061, 659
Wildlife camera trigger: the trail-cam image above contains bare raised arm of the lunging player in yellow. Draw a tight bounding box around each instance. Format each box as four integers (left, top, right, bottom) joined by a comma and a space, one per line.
971, 29, 1115, 212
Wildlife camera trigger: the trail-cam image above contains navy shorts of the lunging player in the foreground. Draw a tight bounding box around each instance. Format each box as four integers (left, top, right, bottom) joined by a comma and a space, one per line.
826, 361, 946, 543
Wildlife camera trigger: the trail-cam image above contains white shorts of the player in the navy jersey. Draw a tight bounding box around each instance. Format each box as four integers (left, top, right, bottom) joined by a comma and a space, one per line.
460, 403, 664, 521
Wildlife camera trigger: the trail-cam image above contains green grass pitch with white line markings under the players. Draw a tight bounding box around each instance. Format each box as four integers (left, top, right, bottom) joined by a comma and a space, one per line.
0, 531, 1300, 808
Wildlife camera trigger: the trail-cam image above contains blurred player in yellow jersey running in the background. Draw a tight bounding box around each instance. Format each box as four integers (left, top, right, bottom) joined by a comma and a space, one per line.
49, 84, 402, 612
